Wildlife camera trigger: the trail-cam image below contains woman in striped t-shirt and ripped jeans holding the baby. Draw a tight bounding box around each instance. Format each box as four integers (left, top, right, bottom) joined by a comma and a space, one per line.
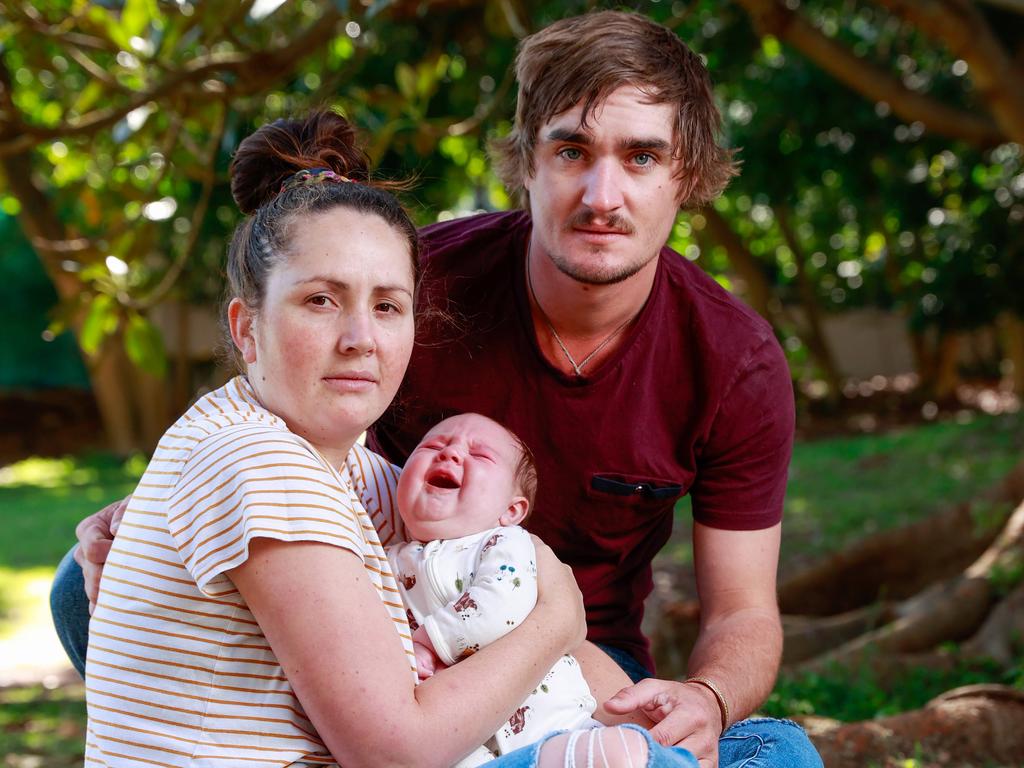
79, 113, 695, 766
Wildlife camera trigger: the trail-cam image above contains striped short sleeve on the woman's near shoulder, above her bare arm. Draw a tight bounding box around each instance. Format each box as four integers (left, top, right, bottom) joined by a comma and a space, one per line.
167, 423, 366, 596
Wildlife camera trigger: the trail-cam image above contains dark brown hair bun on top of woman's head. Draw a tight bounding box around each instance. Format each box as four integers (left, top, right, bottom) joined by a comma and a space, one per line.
230, 110, 370, 215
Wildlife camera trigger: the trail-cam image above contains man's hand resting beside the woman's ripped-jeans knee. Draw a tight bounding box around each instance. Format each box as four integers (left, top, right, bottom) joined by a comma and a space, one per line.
604, 679, 722, 768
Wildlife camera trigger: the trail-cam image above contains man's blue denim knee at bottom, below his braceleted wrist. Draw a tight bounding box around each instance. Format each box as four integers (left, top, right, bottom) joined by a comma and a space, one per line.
718, 718, 821, 768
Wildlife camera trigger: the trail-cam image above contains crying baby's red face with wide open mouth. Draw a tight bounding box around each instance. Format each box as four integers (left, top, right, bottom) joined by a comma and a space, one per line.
398, 414, 526, 542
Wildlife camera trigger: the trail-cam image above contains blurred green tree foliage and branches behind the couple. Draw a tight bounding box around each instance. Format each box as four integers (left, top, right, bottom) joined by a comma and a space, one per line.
0, 0, 1024, 453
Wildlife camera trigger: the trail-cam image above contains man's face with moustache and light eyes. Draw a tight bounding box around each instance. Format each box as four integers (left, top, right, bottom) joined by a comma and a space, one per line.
524, 86, 681, 285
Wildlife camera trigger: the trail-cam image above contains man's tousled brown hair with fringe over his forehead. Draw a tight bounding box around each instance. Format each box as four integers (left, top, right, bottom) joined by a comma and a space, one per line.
492, 10, 738, 208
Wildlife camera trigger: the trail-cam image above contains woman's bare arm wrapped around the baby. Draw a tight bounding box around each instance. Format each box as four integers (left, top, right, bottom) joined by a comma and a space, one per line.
228, 539, 584, 768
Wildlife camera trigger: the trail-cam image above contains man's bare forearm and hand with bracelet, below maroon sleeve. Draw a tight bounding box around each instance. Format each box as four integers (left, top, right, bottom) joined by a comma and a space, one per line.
605, 523, 782, 767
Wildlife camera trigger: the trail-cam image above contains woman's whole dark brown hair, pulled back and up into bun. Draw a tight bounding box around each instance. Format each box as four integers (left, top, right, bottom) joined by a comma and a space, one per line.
221, 111, 420, 368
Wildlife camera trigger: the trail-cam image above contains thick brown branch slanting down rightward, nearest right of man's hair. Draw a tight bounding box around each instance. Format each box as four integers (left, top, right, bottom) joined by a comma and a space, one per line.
738, 0, 1009, 148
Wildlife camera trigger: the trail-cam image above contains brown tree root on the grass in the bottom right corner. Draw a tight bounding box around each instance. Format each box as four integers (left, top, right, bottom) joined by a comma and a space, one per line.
801, 685, 1024, 768
